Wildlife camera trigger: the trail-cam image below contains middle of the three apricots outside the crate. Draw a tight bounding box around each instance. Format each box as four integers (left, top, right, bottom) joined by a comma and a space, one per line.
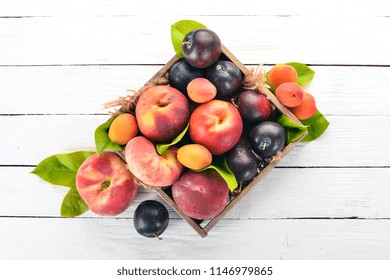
275, 82, 303, 107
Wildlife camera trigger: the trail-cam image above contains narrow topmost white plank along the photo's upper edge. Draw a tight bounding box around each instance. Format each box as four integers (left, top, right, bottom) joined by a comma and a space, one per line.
0, 0, 389, 17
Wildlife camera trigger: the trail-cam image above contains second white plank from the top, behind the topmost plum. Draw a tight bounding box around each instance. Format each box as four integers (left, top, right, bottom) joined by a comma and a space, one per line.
0, 15, 390, 65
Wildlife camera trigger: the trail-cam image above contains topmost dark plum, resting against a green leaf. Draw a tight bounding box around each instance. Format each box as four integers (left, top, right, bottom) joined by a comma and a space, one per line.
182, 28, 222, 68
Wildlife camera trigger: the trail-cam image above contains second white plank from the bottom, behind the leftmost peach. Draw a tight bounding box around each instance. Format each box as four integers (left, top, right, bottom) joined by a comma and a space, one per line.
0, 167, 390, 220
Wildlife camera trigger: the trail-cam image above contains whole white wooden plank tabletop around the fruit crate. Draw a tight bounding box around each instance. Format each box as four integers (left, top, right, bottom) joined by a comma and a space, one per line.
0, 0, 390, 259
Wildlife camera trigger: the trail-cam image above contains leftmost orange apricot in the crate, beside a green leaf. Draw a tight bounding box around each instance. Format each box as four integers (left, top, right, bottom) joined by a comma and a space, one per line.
108, 113, 138, 145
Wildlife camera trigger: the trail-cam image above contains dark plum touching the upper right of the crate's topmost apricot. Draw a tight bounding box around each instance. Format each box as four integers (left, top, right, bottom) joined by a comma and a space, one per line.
206, 60, 242, 98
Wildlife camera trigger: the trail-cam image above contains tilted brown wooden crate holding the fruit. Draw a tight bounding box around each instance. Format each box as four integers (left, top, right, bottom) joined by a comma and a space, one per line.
137, 46, 307, 237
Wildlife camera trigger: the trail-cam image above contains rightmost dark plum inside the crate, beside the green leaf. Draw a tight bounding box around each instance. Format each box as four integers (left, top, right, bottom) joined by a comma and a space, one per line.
249, 121, 286, 159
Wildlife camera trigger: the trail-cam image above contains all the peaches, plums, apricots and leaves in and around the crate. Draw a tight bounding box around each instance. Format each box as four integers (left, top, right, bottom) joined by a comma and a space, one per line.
33, 21, 327, 237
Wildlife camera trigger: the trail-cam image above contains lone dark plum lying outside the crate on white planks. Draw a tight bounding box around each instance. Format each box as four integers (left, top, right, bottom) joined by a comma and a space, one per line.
134, 200, 169, 238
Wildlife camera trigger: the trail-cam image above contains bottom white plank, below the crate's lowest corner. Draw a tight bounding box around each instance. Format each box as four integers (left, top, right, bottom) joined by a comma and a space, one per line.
0, 218, 390, 260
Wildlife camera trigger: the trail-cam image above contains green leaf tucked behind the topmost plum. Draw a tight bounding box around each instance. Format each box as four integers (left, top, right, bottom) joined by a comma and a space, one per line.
171, 19, 206, 58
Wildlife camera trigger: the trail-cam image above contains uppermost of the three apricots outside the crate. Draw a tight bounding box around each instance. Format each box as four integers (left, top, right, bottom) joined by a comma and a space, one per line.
267, 64, 298, 90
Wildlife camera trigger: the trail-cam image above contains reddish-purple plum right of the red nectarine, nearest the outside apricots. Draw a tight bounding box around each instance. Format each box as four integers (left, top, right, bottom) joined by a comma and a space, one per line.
237, 90, 272, 123
